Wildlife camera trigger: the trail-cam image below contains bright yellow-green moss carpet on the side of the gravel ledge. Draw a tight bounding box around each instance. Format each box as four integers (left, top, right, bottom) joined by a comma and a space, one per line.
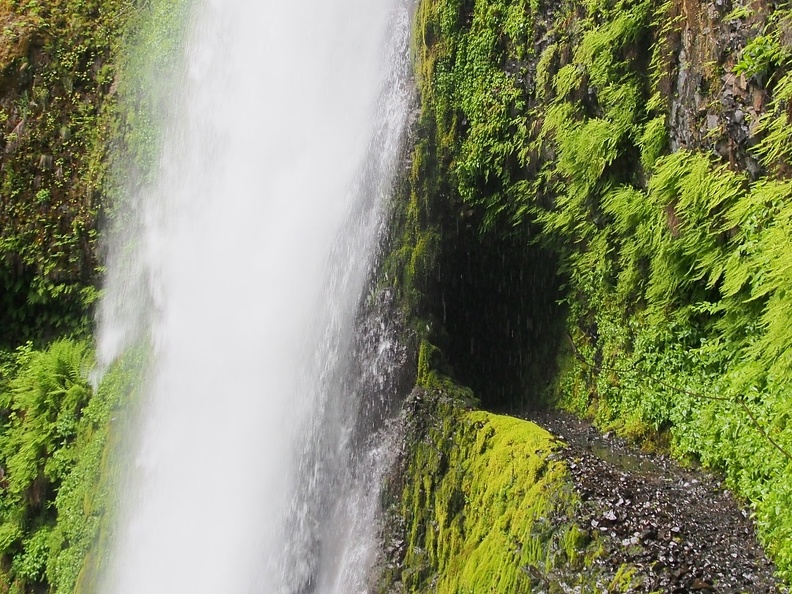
420, 413, 564, 592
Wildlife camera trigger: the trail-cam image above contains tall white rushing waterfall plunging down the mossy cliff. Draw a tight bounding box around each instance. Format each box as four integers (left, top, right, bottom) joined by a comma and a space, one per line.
98, 0, 411, 594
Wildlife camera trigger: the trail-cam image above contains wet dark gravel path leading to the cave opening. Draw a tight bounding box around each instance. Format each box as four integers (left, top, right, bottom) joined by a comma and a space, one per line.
523, 411, 788, 594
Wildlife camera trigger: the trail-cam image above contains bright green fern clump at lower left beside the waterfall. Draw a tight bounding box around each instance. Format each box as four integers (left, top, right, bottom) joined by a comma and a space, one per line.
0, 340, 141, 594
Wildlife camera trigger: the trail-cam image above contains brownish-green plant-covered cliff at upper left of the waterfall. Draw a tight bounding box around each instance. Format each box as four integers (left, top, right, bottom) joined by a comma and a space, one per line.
0, 0, 188, 347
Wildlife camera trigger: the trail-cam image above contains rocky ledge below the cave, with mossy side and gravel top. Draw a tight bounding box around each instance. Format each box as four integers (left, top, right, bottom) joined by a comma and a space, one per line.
372, 388, 788, 594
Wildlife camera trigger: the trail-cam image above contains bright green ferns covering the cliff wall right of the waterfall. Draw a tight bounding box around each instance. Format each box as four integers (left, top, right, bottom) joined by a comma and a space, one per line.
406, 0, 792, 580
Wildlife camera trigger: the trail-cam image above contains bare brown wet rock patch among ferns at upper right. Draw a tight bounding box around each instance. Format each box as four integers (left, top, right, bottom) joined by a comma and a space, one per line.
661, 0, 769, 178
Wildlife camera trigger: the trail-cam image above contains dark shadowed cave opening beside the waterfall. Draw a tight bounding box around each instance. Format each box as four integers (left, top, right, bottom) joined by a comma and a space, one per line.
430, 220, 564, 413
